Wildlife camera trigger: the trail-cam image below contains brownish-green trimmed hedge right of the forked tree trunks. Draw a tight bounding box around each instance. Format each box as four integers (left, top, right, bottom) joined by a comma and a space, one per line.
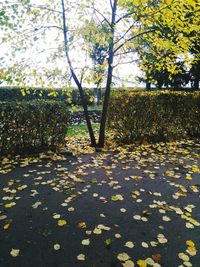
108, 91, 200, 144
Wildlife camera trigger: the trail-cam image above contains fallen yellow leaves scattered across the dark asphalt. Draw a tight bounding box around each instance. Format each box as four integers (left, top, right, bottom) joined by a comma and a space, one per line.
0, 140, 200, 267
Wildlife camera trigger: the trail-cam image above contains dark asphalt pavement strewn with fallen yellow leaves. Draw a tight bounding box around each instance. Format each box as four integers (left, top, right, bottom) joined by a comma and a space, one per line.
0, 142, 200, 267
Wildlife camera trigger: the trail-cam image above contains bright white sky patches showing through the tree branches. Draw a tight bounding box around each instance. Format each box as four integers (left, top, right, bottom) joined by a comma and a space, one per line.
0, 0, 141, 87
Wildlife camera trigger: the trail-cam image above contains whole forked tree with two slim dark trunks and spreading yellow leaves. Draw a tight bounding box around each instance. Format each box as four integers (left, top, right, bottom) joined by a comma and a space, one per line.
0, 0, 200, 147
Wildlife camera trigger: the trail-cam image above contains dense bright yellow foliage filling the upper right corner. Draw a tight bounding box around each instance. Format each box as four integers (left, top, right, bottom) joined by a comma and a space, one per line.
122, 0, 200, 74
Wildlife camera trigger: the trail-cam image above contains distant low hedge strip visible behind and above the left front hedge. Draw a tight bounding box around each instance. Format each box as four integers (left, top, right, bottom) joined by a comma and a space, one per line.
0, 87, 95, 105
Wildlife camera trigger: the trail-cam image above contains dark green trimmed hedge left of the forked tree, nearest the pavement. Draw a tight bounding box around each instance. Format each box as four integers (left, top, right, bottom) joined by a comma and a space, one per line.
0, 100, 69, 156
